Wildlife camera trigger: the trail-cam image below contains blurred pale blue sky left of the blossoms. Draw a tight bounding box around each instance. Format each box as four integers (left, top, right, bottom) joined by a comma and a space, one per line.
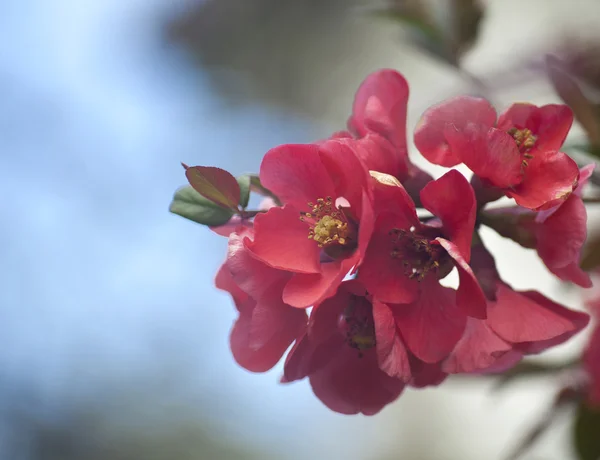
0, 0, 384, 454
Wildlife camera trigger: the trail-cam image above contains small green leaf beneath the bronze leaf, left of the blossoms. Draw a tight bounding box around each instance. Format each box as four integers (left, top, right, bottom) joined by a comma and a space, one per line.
169, 185, 234, 227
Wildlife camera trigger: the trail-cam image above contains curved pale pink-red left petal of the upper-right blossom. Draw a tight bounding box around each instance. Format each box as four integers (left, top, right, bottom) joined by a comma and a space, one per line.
414, 96, 496, 167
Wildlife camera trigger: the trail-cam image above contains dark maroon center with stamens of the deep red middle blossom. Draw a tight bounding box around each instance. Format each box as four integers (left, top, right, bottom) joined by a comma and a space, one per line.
389, 227, 446, 281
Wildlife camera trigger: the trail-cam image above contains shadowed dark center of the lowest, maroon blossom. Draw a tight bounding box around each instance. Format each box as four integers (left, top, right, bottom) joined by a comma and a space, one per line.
338, 297, 376, 356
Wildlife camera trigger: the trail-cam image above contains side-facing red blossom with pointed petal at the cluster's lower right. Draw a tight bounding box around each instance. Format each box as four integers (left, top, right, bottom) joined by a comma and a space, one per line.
442, 241, 589, 374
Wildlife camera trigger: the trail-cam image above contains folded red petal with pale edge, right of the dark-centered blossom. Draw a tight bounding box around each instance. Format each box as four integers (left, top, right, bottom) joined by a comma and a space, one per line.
436, 238, 487, 319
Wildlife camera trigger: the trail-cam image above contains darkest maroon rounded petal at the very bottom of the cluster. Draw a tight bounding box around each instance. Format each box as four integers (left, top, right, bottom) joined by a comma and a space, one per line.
309, 346, 404, 415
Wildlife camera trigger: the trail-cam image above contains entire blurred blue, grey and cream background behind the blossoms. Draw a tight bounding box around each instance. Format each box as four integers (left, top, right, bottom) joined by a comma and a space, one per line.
0, 0, 600, 460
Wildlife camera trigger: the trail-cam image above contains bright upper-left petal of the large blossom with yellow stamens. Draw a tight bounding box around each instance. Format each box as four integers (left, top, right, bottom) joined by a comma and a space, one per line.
260, 144, 335, 211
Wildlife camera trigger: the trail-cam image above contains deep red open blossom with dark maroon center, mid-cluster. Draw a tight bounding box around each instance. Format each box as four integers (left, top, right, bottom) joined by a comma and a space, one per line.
358, 171, 486, 363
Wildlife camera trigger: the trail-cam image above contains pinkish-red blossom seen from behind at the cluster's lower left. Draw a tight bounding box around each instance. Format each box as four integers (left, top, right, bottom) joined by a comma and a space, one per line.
215, 229, 307, 372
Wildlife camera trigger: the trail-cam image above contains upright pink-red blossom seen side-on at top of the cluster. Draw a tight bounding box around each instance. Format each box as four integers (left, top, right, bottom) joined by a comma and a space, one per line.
336, 69, 432, 199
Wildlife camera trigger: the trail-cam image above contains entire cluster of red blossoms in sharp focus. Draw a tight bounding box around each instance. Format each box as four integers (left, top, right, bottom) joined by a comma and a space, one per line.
176, 70, 600, 415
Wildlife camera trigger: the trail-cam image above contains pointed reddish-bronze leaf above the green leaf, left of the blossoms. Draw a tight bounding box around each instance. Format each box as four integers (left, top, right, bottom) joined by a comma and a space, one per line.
184, 165, 240, 209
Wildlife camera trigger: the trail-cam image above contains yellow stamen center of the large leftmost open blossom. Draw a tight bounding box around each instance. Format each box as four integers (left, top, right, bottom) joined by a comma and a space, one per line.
300, 196, 353, 248
